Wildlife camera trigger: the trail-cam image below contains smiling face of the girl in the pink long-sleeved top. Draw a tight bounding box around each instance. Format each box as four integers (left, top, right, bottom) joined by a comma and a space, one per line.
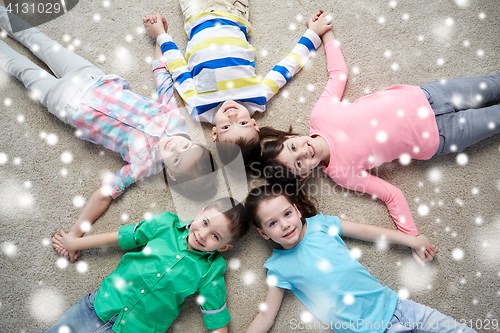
277, 136, 329, 177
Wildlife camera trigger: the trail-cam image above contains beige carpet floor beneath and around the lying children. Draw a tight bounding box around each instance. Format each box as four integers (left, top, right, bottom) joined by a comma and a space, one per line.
0, 0, 500, 333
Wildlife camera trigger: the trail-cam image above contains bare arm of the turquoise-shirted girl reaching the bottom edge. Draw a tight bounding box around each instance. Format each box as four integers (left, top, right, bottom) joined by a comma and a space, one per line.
246, 286, 285, 333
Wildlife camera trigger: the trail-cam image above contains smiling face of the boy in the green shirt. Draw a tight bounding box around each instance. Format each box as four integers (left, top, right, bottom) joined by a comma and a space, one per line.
187, 208, 233, 252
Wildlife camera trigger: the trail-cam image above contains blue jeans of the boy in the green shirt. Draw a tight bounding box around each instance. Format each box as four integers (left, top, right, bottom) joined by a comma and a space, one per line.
45, 291, 118, 333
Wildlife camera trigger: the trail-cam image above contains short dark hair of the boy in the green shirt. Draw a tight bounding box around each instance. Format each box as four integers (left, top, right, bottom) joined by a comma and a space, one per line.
205, 197, 250, 241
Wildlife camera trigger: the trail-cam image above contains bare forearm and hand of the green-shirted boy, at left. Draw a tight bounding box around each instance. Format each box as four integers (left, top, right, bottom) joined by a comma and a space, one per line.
52, 229, 119, 263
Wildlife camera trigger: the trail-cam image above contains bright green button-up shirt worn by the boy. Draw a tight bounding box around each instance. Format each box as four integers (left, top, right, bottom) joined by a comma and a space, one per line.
94, 213, 231, 333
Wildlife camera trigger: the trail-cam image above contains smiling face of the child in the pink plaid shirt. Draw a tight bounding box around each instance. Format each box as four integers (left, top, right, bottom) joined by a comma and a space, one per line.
159, 135, 203, 179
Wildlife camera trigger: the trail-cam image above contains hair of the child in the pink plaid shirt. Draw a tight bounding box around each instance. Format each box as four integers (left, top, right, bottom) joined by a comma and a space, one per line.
163, 144, 218, 201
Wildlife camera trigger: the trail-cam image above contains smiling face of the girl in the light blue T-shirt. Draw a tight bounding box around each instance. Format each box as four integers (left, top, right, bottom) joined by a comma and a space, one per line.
256, 195, 306, 250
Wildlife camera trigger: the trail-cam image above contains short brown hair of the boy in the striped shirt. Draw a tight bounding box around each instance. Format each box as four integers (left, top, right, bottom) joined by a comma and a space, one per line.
216, 135, 262, 171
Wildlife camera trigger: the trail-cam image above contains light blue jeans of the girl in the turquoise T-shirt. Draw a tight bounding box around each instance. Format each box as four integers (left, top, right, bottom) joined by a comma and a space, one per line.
385, 300, 476, 333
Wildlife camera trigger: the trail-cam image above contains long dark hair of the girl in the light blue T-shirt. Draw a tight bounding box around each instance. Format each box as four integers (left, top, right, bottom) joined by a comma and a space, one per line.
245, 184, 318, 228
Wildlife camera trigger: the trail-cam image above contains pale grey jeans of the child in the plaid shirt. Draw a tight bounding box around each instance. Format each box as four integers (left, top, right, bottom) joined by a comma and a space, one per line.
0, 6, 104, 126
